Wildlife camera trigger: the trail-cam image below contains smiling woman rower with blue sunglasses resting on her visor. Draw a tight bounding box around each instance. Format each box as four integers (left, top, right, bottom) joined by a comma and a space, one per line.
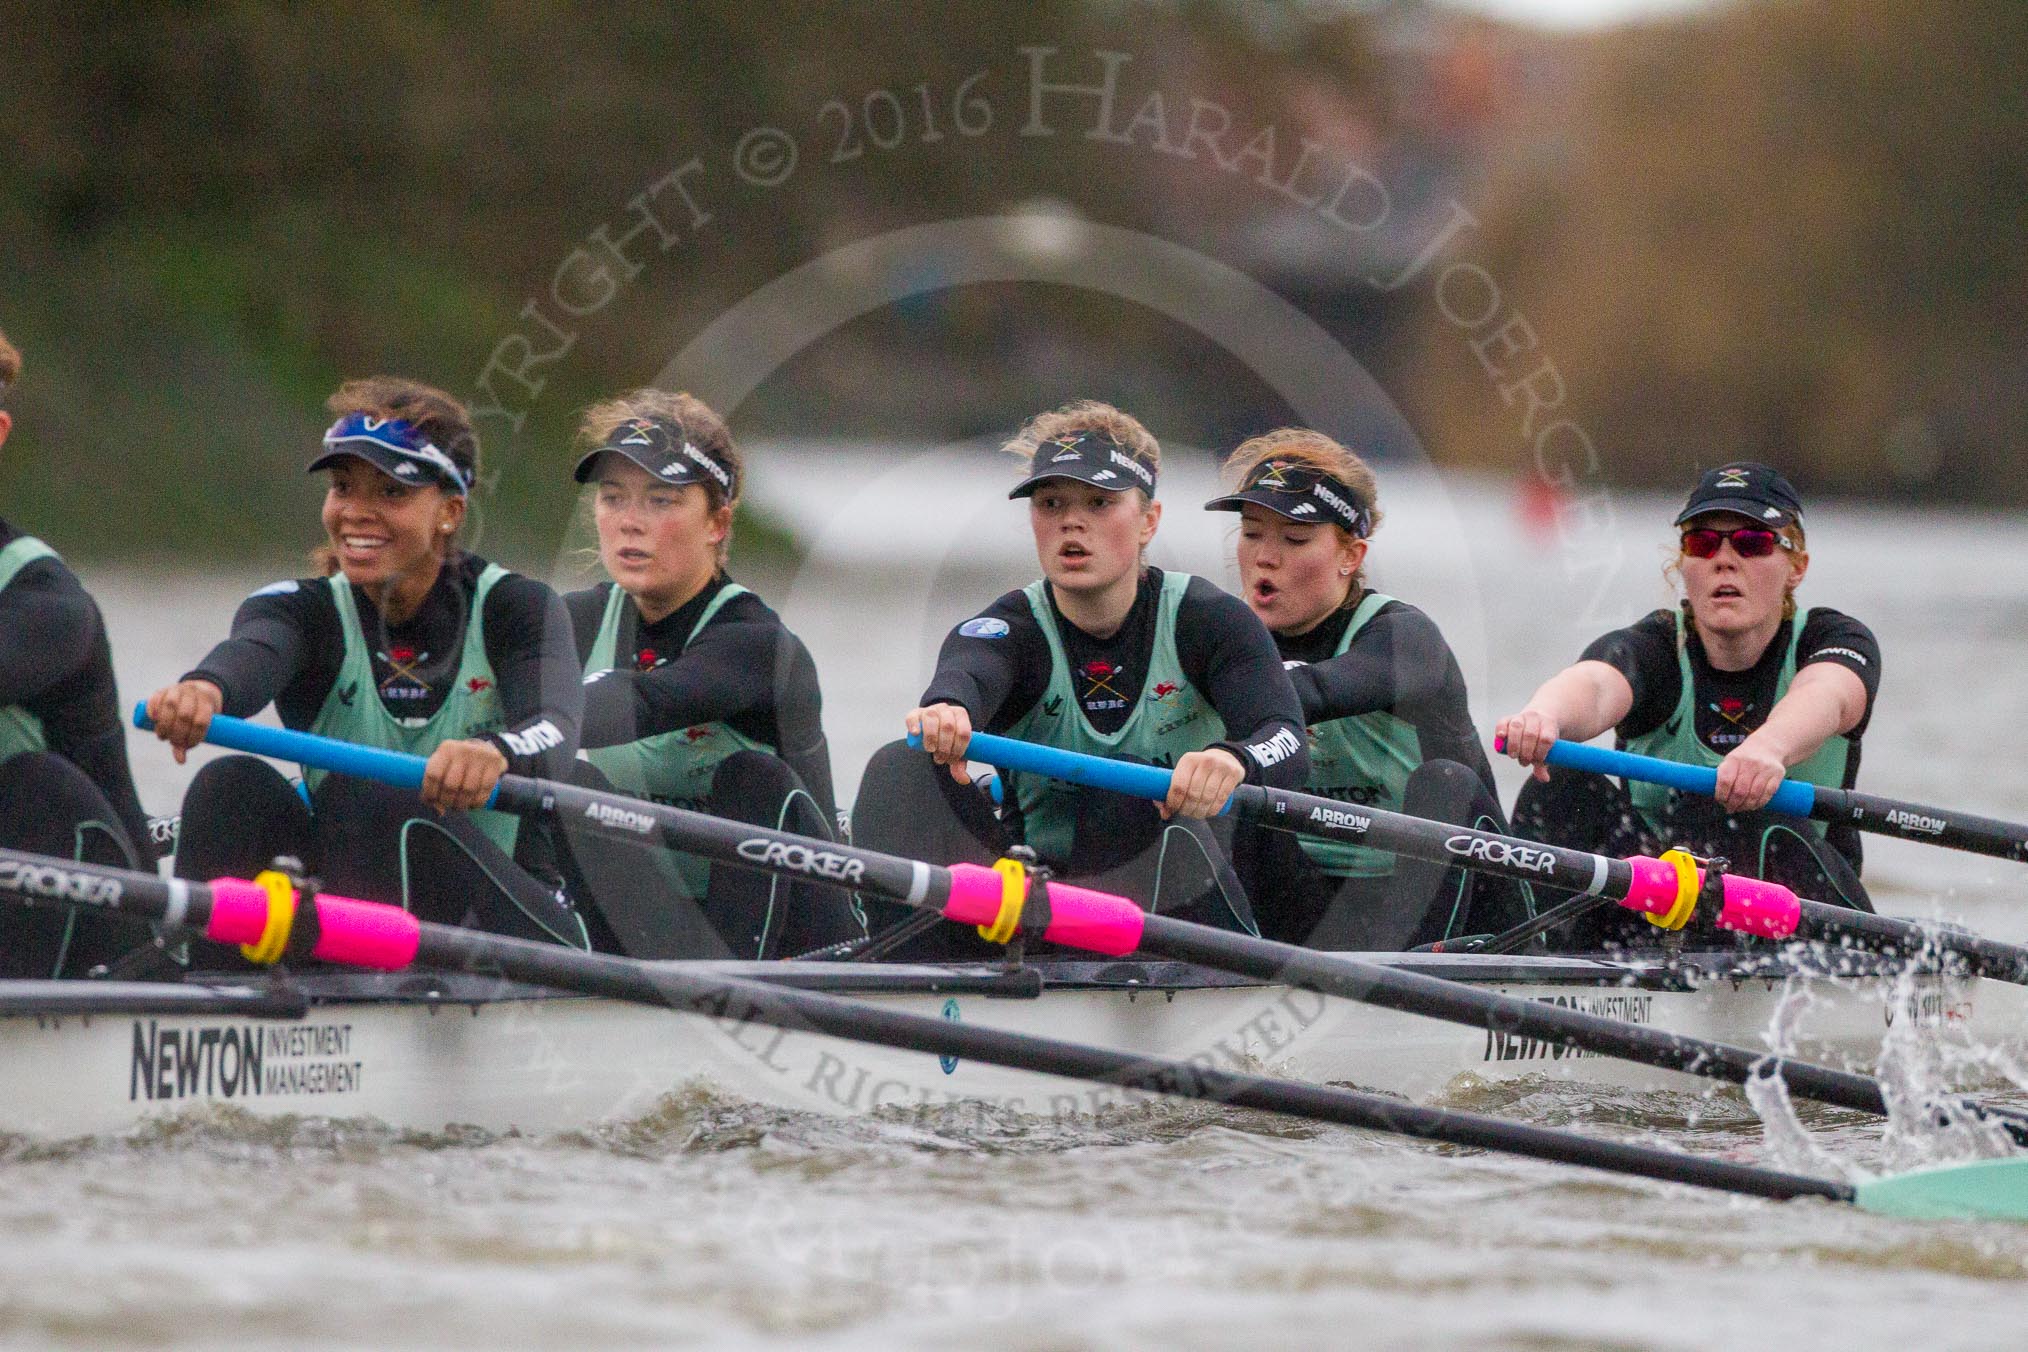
148, 377, 588, 947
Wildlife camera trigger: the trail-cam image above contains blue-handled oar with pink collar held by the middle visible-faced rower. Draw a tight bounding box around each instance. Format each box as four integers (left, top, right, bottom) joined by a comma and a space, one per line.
936, 732, 2028, 985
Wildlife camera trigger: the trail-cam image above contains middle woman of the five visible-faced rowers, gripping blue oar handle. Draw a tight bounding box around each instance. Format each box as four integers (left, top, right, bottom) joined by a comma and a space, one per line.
854, 401, 1308, 953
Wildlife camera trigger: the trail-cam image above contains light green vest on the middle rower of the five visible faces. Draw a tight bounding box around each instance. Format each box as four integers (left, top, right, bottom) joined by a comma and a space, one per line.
1008, 574, 1225, 866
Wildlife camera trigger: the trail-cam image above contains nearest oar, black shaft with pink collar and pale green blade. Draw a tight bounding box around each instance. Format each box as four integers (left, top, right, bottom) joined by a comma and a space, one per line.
0, 835, 2028, 1220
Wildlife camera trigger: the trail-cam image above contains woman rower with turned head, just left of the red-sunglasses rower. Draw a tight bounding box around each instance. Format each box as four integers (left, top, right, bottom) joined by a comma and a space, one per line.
1205, 428, 1533, 953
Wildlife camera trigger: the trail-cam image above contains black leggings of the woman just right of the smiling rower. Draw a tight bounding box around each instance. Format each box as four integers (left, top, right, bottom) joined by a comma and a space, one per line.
564, 750, 866, 959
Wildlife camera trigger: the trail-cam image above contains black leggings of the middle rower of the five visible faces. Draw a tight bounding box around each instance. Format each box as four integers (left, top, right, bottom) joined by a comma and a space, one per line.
852, 742, 1257, 961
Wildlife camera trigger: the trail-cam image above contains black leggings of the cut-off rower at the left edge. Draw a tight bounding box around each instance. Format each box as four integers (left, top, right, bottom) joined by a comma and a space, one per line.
0, 752, 154, 979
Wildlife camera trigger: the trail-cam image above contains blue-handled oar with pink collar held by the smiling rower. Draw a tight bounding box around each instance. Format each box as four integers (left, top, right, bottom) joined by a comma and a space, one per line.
142, 716, 2028, 1143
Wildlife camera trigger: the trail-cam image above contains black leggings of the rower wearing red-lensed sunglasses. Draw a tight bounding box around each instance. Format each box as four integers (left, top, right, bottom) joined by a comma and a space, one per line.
1515, 770, 1874, 949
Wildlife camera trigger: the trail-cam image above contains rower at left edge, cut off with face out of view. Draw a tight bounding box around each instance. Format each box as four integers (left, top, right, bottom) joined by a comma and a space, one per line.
0, 324, 154, 979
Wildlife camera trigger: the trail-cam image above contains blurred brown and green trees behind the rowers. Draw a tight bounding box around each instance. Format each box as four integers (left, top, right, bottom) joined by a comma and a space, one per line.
0, 0, 2028, 557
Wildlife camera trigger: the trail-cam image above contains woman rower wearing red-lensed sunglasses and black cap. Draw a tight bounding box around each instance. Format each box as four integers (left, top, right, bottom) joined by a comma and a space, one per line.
1497, 462, 1880, 947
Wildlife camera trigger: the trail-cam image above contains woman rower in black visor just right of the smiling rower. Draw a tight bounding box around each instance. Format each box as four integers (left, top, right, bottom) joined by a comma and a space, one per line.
564, 389, 864, 959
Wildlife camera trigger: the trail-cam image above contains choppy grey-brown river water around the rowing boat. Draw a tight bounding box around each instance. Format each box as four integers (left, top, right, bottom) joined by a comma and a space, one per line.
0, 458, 2028, 1348
